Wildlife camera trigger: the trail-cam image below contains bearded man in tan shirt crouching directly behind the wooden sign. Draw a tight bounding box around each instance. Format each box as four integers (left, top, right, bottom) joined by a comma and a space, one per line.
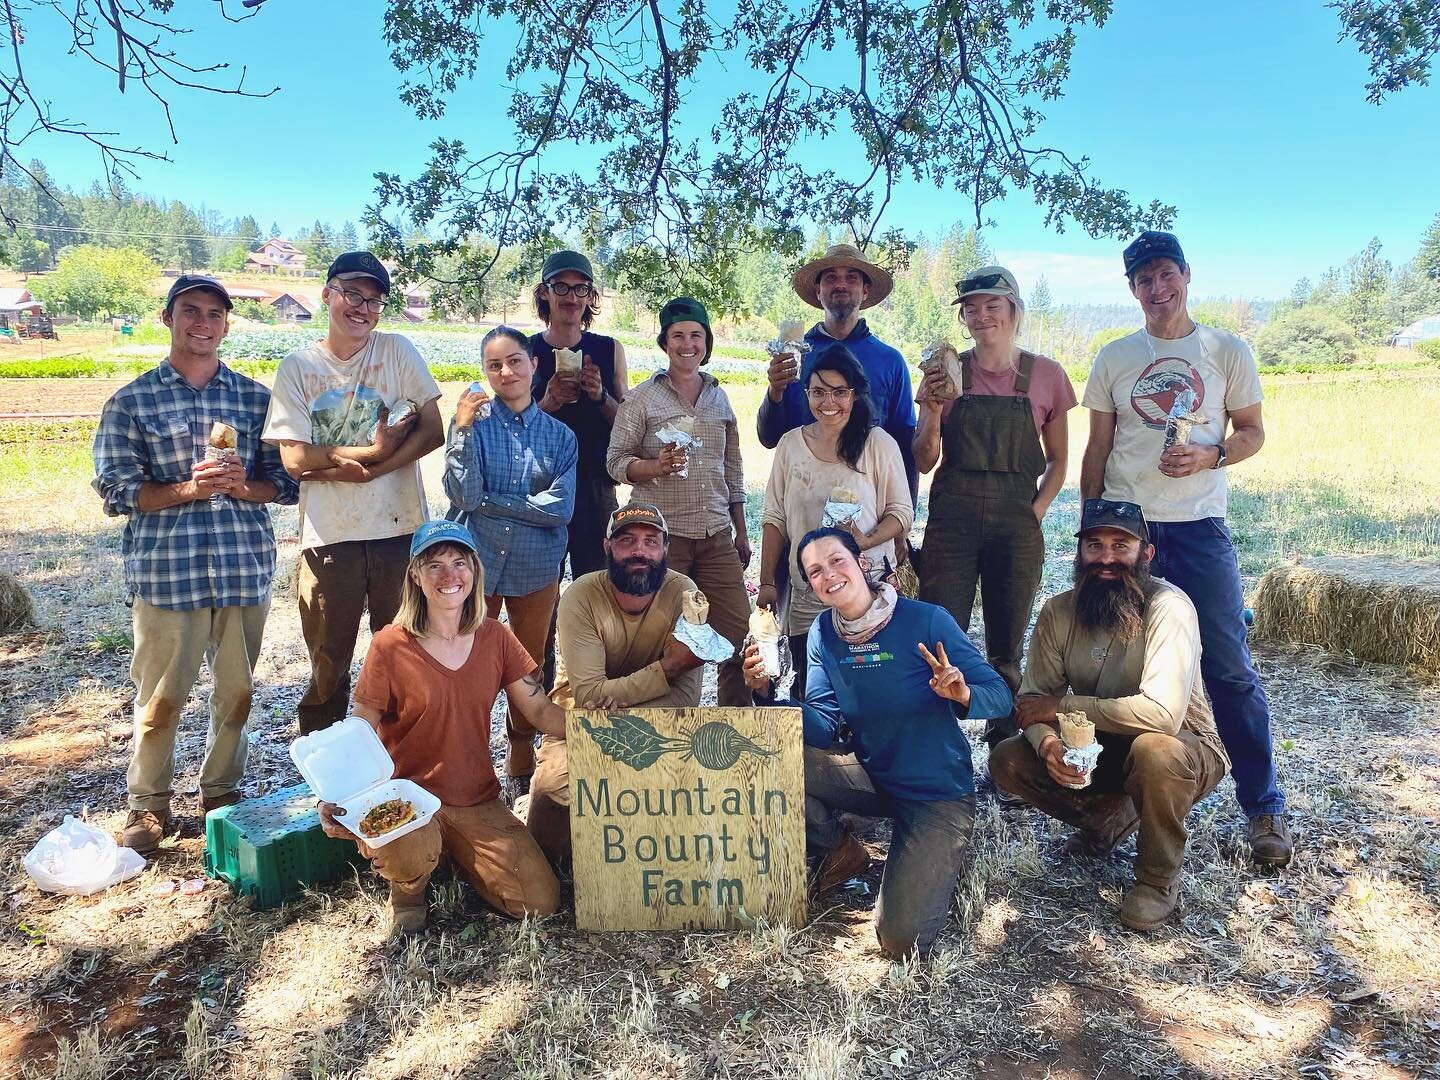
526, 503, 704, 861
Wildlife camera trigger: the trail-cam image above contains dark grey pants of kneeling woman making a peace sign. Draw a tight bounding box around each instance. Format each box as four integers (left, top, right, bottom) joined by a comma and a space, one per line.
805, 746, 975, 956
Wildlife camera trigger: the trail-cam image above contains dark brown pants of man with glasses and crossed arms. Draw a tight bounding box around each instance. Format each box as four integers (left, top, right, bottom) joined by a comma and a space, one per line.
297, 536, 410, 734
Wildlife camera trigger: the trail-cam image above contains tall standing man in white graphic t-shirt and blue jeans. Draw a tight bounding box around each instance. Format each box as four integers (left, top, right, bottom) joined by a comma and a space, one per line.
1080, 232, 1292, 865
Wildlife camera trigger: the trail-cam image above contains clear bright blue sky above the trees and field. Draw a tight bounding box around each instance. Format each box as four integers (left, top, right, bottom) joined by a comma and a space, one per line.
14, 0, 1440, 302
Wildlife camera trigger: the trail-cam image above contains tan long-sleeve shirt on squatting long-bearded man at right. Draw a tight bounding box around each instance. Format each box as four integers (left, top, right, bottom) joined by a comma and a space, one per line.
1020, 582, 1230, 768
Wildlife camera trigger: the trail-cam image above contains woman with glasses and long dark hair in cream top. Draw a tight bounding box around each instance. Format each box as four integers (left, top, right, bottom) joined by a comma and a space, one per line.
755, 346, 914, 698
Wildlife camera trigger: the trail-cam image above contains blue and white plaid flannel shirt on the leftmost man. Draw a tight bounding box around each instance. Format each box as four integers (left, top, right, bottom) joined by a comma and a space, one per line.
92, 360, 300, 611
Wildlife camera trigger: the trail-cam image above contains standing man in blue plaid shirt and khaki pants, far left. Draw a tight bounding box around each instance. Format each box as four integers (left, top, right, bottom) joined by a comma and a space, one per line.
94, 275, 300, 854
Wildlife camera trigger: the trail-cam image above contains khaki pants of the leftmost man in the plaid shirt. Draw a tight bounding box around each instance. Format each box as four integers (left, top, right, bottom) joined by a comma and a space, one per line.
125, 596, 269, 812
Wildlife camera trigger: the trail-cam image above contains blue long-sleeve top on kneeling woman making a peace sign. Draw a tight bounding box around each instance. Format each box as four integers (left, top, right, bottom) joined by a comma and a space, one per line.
801, 598, 1012, 802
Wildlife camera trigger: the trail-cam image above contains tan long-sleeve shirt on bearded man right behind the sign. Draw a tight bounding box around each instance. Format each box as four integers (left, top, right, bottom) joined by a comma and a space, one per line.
550, 570, 704, 708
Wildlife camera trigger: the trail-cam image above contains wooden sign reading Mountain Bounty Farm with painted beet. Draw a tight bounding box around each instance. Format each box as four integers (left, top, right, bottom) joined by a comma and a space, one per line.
564, 708, 805, 930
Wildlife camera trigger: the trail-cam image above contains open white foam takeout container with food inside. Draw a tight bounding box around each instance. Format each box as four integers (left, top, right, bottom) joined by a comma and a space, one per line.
289, 716, 441, 848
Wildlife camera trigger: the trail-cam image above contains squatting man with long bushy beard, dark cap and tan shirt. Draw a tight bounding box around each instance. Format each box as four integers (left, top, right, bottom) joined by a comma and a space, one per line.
991, 498, 1230, 930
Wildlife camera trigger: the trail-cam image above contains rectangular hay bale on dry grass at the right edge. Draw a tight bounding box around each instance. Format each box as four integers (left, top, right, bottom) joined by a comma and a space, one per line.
1254, 554, 1440, 678
